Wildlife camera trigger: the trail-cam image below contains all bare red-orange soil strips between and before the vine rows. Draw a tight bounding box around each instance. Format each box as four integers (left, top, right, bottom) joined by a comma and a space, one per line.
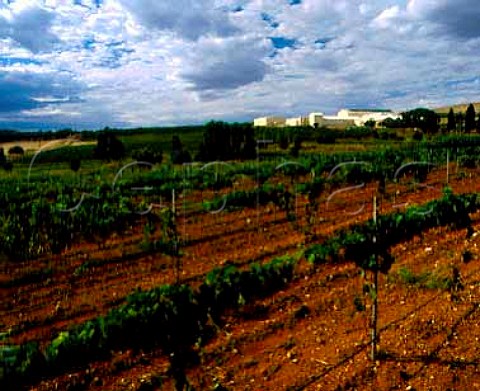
0, 164, 480, 390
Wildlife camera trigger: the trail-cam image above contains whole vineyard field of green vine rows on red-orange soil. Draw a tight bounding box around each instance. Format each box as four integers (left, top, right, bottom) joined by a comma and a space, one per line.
0, 135, 480, 390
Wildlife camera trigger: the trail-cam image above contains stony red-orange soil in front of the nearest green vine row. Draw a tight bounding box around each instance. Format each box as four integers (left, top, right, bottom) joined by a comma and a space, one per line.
34, 214, 480, 390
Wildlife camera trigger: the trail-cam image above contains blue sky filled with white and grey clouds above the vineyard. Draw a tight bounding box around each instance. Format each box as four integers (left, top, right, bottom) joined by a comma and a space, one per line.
0, 0, 480, 130
